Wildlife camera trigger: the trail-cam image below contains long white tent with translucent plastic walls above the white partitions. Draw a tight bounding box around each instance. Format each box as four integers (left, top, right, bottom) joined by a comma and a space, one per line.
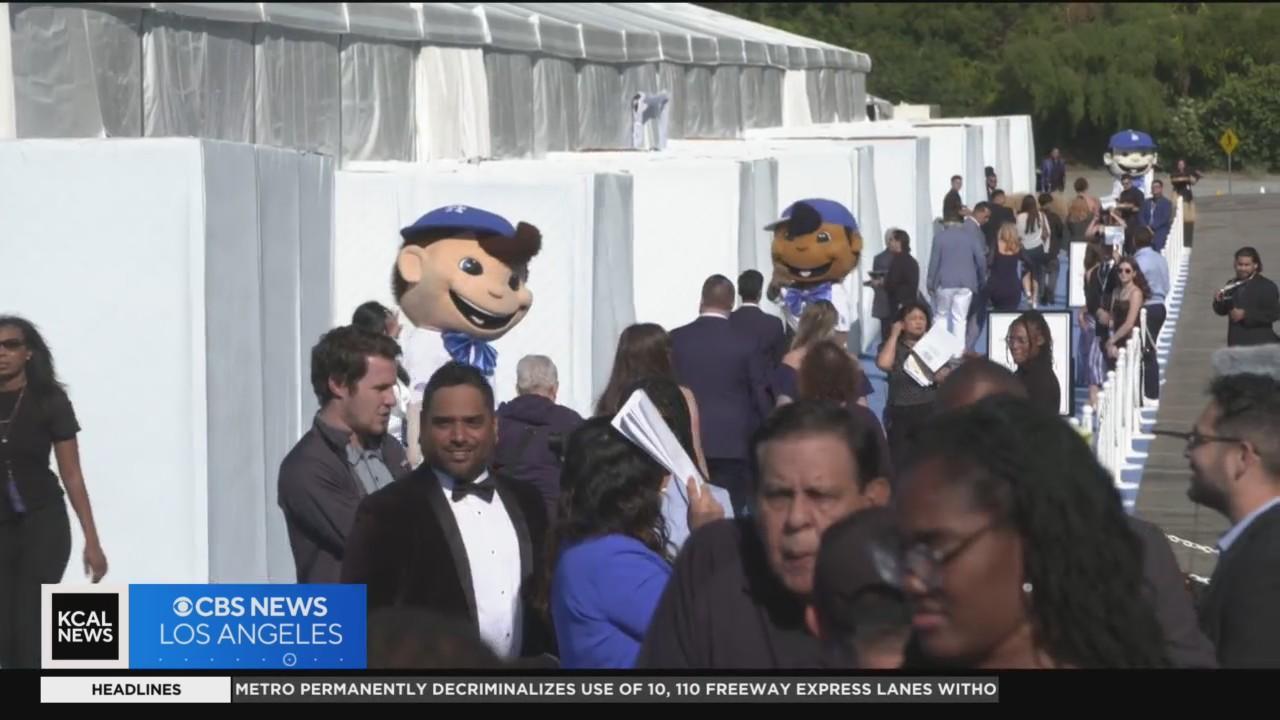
0, 3, 870, 163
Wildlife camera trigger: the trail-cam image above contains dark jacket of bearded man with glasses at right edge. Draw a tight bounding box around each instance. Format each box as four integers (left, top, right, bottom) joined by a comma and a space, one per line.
1199, 506, 1280, 667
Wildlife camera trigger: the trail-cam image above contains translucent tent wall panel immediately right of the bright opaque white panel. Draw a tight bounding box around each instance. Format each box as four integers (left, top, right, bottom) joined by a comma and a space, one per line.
484, 53, 536, 158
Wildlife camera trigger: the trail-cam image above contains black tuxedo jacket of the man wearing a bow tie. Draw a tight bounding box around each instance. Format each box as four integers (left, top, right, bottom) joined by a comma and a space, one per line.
342, 464, 553, 657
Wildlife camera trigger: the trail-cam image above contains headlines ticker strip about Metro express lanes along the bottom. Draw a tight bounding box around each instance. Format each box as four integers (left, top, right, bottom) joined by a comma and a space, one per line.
40, 675, 1000, 703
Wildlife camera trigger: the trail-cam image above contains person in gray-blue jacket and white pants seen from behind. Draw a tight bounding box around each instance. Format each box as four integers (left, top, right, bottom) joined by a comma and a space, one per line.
927, 208, 987, 346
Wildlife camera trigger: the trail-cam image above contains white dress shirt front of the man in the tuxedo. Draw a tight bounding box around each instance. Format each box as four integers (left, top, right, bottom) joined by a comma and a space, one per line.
433, 468, 524, 657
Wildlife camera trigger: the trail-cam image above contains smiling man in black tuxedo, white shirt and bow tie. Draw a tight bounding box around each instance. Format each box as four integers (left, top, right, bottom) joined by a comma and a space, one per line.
342, 363, 552, 657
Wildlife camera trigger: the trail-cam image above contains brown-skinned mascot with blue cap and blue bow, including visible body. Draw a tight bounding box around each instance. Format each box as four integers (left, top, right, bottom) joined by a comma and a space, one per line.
764, 199, 863, 336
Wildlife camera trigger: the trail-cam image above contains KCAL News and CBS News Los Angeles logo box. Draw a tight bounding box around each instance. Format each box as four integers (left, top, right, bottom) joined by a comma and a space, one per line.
41, 584, 366, 670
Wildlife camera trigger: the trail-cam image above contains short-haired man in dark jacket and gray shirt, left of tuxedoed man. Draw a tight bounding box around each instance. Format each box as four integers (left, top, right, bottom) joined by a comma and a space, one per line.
278, 325, 410, 583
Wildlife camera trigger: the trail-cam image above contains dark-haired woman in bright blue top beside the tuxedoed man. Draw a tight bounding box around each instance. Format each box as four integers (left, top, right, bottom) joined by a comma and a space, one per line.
549, 418, 701, 669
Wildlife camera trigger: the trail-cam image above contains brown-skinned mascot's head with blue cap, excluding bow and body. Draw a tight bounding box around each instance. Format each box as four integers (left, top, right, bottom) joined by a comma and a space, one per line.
764, 199, 863, 286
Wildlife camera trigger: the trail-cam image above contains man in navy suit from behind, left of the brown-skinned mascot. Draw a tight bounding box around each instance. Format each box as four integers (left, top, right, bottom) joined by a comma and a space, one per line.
671, 275, 772, 515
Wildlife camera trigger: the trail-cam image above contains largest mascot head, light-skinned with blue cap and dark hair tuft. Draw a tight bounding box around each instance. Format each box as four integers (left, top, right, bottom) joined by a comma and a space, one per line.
392, 205, 543, 340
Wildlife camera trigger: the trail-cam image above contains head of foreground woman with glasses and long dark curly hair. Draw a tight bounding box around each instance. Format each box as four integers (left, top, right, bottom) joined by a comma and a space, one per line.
897, 396, 1169, 669
